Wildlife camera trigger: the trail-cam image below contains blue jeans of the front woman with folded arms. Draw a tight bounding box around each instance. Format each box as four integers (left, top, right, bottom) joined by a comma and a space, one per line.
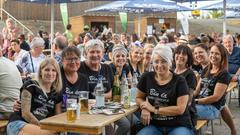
137, 125, 194, 135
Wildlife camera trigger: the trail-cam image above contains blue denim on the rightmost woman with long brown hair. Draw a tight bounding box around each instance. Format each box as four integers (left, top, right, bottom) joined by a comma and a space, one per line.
196, 105, 220, 120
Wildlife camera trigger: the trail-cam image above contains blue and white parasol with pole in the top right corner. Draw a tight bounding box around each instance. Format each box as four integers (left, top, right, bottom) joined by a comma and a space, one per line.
199, 0, 240, 35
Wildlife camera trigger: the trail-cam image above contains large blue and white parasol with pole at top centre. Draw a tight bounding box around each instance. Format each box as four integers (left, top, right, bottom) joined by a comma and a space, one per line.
85, 0, 191, 36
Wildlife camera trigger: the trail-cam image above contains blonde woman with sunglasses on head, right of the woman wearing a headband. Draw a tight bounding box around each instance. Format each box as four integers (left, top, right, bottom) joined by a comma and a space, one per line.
128, 41, 144, 77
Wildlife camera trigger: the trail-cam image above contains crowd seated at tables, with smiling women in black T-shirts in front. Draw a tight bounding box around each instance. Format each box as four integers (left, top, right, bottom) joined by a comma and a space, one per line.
0, 20, 240, 135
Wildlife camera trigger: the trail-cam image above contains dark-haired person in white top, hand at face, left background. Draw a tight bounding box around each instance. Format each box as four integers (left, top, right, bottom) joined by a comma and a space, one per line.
8, 39, 27, 65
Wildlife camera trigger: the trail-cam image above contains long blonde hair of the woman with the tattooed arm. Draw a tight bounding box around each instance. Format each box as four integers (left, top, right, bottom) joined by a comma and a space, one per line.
37, 58, 62, 92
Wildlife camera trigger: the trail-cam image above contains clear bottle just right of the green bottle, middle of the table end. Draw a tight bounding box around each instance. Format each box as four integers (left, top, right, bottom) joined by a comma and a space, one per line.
120, 71, 130, 109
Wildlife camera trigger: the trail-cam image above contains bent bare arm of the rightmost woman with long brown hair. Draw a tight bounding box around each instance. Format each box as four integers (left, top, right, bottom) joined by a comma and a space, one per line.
196, 83, 228, 104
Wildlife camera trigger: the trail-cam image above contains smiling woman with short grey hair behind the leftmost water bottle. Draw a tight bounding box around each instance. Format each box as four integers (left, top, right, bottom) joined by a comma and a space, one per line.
79, 39, 137, 135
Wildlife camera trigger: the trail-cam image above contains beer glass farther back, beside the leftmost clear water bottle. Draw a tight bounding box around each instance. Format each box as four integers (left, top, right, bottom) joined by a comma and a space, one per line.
79, 91, 89, 113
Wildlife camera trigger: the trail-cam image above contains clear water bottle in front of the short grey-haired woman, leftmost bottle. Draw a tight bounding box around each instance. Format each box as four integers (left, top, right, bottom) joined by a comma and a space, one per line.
94, 79, 105, 107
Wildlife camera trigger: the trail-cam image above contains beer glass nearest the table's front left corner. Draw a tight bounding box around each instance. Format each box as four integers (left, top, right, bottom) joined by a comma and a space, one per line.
67, 99, 77, 122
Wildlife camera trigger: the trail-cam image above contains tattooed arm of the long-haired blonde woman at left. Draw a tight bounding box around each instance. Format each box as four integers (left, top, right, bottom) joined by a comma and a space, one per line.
21, 90, 39, 125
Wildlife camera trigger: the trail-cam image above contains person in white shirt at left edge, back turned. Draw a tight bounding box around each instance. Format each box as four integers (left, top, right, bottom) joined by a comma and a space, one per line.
0, 46, 22, 119
